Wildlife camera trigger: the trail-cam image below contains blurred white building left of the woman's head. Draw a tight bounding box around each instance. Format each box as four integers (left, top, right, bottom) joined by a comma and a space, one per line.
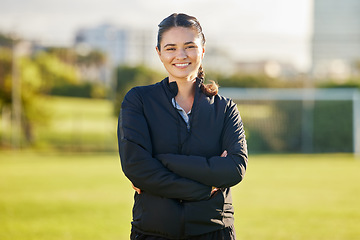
75, 24, 159, 86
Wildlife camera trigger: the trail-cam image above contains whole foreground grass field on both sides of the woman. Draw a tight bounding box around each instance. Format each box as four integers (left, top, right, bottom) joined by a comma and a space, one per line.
0, 152, 360, 240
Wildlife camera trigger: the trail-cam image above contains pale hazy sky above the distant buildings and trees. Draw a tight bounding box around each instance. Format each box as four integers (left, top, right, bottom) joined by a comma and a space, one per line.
0, 0, 312, 70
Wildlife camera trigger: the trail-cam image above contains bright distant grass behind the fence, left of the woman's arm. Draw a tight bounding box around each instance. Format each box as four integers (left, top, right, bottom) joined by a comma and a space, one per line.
0, 97, 117, 152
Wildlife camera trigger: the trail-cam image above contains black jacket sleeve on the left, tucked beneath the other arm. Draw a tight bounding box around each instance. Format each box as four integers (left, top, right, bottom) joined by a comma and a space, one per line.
118, 89, 211, 201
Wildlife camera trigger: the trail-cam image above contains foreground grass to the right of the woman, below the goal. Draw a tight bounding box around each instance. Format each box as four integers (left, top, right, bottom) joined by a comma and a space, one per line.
234, 154, 360, 240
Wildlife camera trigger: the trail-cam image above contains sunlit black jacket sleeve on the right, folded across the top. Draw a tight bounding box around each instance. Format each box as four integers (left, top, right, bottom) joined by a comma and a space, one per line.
156, 98, 248, 188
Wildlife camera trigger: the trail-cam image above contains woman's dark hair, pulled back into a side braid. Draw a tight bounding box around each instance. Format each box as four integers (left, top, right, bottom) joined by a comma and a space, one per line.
157, 13, 218, 96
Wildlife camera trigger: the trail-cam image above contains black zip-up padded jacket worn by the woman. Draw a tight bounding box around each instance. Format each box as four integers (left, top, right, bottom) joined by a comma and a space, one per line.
118, 78, 247, 239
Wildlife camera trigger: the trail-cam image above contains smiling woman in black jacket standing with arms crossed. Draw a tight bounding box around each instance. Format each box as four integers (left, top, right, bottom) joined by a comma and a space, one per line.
118, 14, 247, 240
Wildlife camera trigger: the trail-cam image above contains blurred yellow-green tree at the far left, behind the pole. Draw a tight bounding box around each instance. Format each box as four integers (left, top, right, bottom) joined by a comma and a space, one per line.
0, 34, 79, 143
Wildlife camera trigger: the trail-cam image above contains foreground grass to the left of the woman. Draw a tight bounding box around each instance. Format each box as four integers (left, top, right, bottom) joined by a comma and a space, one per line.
0, 153, 132, 240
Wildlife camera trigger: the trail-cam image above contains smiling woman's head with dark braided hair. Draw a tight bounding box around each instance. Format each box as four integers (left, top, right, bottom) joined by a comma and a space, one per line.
156, 14, 218, 102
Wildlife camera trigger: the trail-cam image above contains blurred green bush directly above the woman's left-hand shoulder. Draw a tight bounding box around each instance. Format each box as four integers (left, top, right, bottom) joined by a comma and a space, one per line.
114, 66, 164, 116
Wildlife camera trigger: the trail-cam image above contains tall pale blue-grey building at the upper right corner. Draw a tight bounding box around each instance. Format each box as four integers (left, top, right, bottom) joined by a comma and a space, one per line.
312, 0, 360, 79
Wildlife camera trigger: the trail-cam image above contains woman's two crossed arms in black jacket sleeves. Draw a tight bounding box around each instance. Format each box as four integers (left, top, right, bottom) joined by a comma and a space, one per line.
118, 89, 247, 201
